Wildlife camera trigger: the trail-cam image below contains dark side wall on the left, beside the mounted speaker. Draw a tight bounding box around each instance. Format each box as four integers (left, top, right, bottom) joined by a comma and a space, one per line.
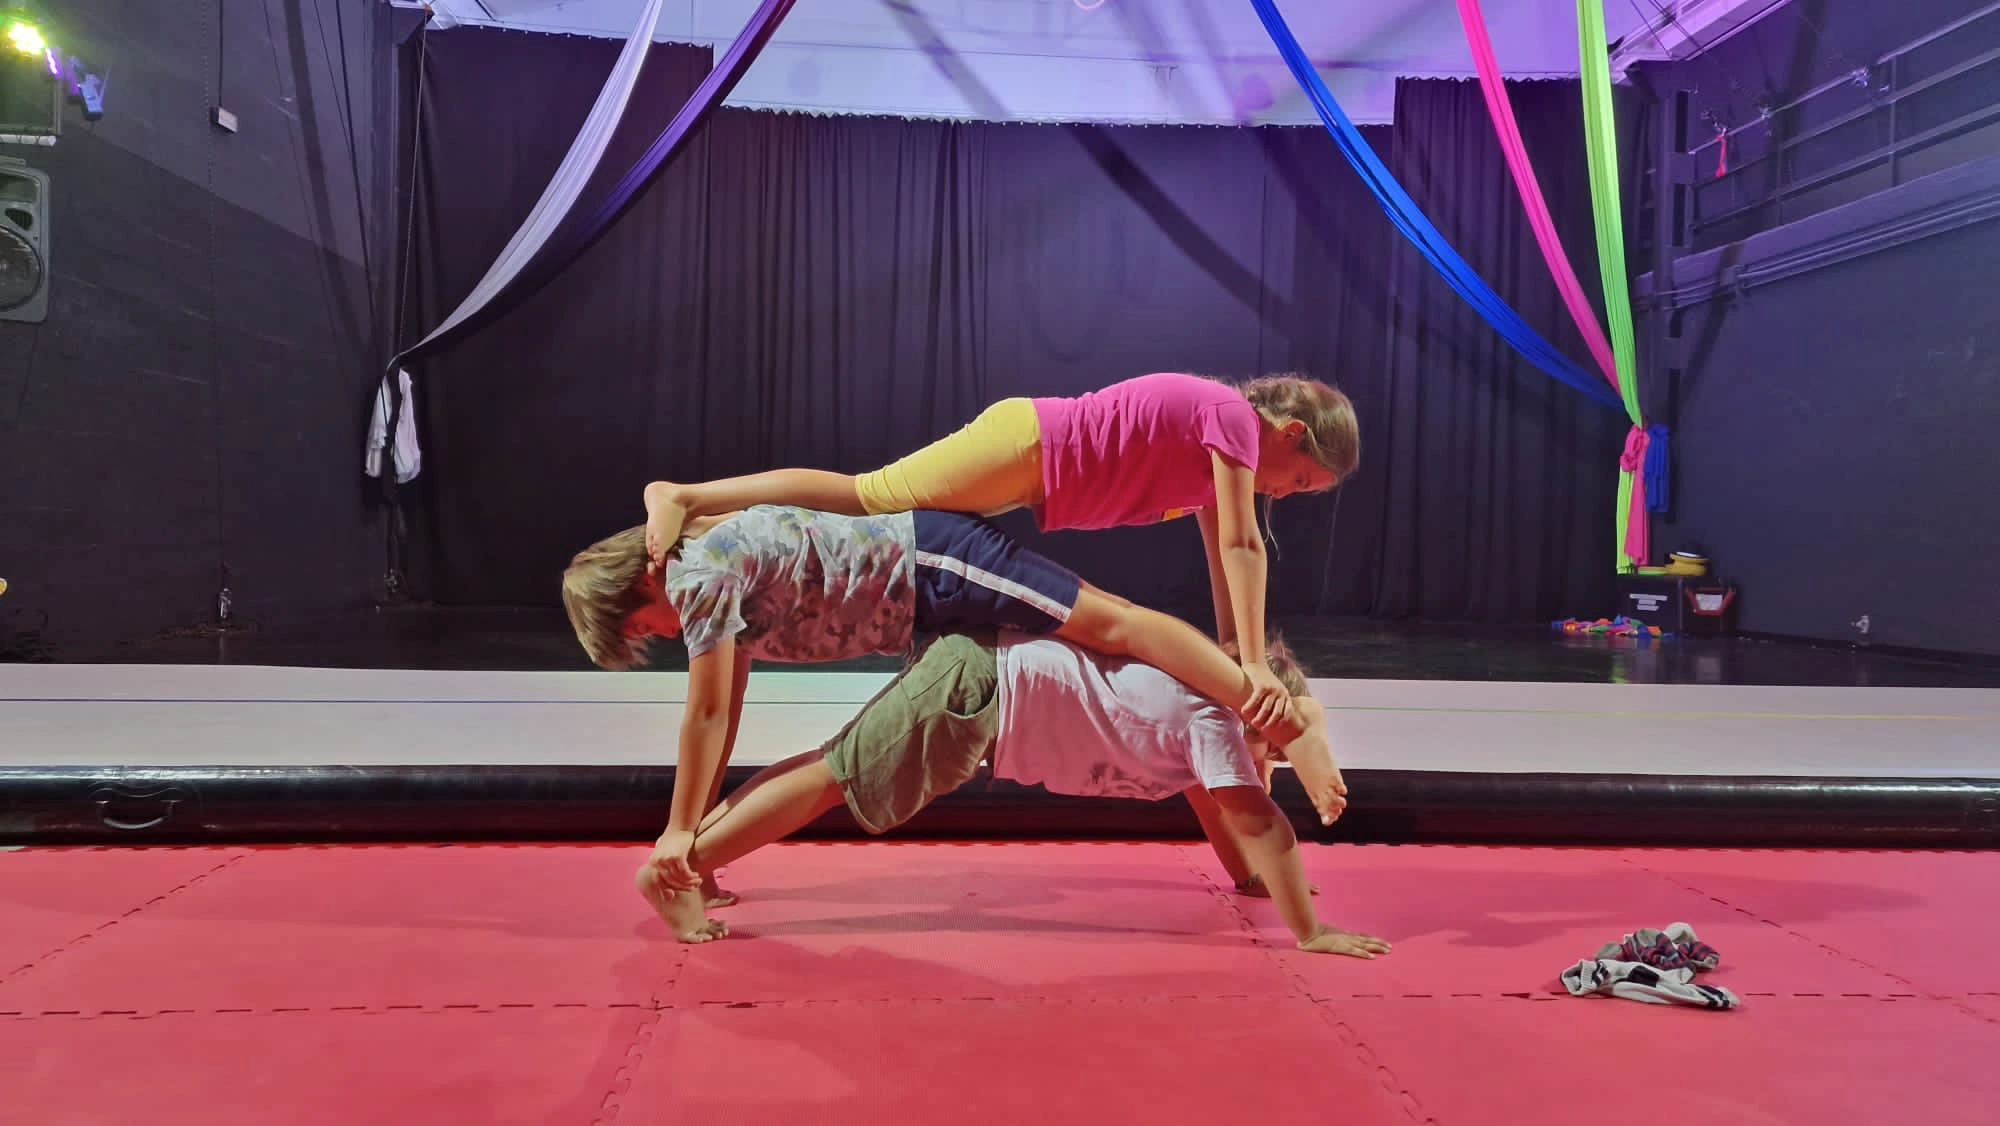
0, 0, 420, 660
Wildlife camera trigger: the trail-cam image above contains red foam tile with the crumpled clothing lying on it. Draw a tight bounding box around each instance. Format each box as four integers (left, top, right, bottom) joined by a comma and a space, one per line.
1272, 846, 1910, 998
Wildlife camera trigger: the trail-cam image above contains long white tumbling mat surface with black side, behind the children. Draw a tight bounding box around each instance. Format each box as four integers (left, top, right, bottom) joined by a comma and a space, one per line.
0, 664, 2000, 778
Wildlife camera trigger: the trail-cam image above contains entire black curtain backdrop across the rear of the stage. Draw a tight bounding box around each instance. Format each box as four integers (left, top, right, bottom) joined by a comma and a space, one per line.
402, 32, 1622, 636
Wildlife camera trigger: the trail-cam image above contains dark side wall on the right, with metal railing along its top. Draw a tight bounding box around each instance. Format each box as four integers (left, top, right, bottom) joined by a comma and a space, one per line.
1646, 0, 2000, 654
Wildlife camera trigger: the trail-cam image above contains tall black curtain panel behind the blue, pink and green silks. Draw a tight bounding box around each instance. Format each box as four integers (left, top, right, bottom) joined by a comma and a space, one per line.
1354, 80, 1628, 620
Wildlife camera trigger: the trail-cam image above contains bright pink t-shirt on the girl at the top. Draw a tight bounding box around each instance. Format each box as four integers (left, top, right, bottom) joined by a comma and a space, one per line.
1034, 372, 1258, 532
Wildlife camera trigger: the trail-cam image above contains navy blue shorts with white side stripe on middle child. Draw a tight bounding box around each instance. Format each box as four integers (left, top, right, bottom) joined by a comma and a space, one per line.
910, 508, 1084, 634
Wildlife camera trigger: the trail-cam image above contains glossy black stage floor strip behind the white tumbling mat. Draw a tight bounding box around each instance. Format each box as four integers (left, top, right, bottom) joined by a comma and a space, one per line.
14, 606, 2000, 688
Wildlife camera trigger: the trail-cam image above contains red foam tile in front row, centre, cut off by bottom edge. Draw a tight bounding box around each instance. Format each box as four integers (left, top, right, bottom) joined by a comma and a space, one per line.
618, 998, 1414, 1126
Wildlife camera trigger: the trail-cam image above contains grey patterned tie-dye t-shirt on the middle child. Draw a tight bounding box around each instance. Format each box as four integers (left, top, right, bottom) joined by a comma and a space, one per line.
664, 504, 916, 664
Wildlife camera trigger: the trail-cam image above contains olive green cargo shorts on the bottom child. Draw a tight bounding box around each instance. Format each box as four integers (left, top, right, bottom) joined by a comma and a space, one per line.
822, 634, 1000, 834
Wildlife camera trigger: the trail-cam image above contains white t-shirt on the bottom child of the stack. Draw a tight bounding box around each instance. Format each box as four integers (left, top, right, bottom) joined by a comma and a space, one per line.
992, 632, 1264, 800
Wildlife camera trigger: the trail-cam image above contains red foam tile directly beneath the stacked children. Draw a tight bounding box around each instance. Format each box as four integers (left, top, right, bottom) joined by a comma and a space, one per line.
670, 842, 1290, 1004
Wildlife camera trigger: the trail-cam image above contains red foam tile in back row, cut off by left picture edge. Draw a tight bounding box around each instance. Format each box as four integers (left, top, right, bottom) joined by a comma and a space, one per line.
0, 848, 242, 992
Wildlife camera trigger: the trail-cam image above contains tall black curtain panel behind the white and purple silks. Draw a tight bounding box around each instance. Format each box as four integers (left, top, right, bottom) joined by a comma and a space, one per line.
396, 28, 712, 606
